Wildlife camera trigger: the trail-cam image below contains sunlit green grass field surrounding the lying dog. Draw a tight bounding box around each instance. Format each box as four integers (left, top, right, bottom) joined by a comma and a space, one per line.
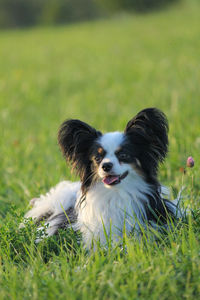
0, 1, 200, 300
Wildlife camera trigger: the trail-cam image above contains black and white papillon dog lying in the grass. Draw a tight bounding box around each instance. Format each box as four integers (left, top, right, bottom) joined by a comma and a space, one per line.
25, 108, 177, 248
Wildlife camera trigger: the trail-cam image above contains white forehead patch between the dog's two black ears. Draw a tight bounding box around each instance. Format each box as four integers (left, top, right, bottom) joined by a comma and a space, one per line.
99, 131, 124, 153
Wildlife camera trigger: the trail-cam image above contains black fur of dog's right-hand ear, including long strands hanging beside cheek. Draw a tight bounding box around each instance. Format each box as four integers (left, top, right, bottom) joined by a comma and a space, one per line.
125, 108, 168, 184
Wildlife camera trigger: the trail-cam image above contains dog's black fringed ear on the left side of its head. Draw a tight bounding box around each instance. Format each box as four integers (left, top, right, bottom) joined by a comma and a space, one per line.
58, 119, 101, 174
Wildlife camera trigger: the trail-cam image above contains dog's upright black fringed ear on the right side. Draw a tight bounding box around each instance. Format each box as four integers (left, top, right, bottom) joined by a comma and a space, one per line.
125, 108, 168, 167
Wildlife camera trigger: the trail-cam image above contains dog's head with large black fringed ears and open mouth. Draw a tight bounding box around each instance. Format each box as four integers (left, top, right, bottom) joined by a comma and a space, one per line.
58, 108, 168, 192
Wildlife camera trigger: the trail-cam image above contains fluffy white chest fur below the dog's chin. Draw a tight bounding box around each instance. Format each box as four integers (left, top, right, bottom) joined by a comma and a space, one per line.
77, 176, 148, 246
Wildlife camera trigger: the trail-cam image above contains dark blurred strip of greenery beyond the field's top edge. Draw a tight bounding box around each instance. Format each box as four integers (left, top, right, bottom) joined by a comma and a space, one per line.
0, 0, 178, 28
